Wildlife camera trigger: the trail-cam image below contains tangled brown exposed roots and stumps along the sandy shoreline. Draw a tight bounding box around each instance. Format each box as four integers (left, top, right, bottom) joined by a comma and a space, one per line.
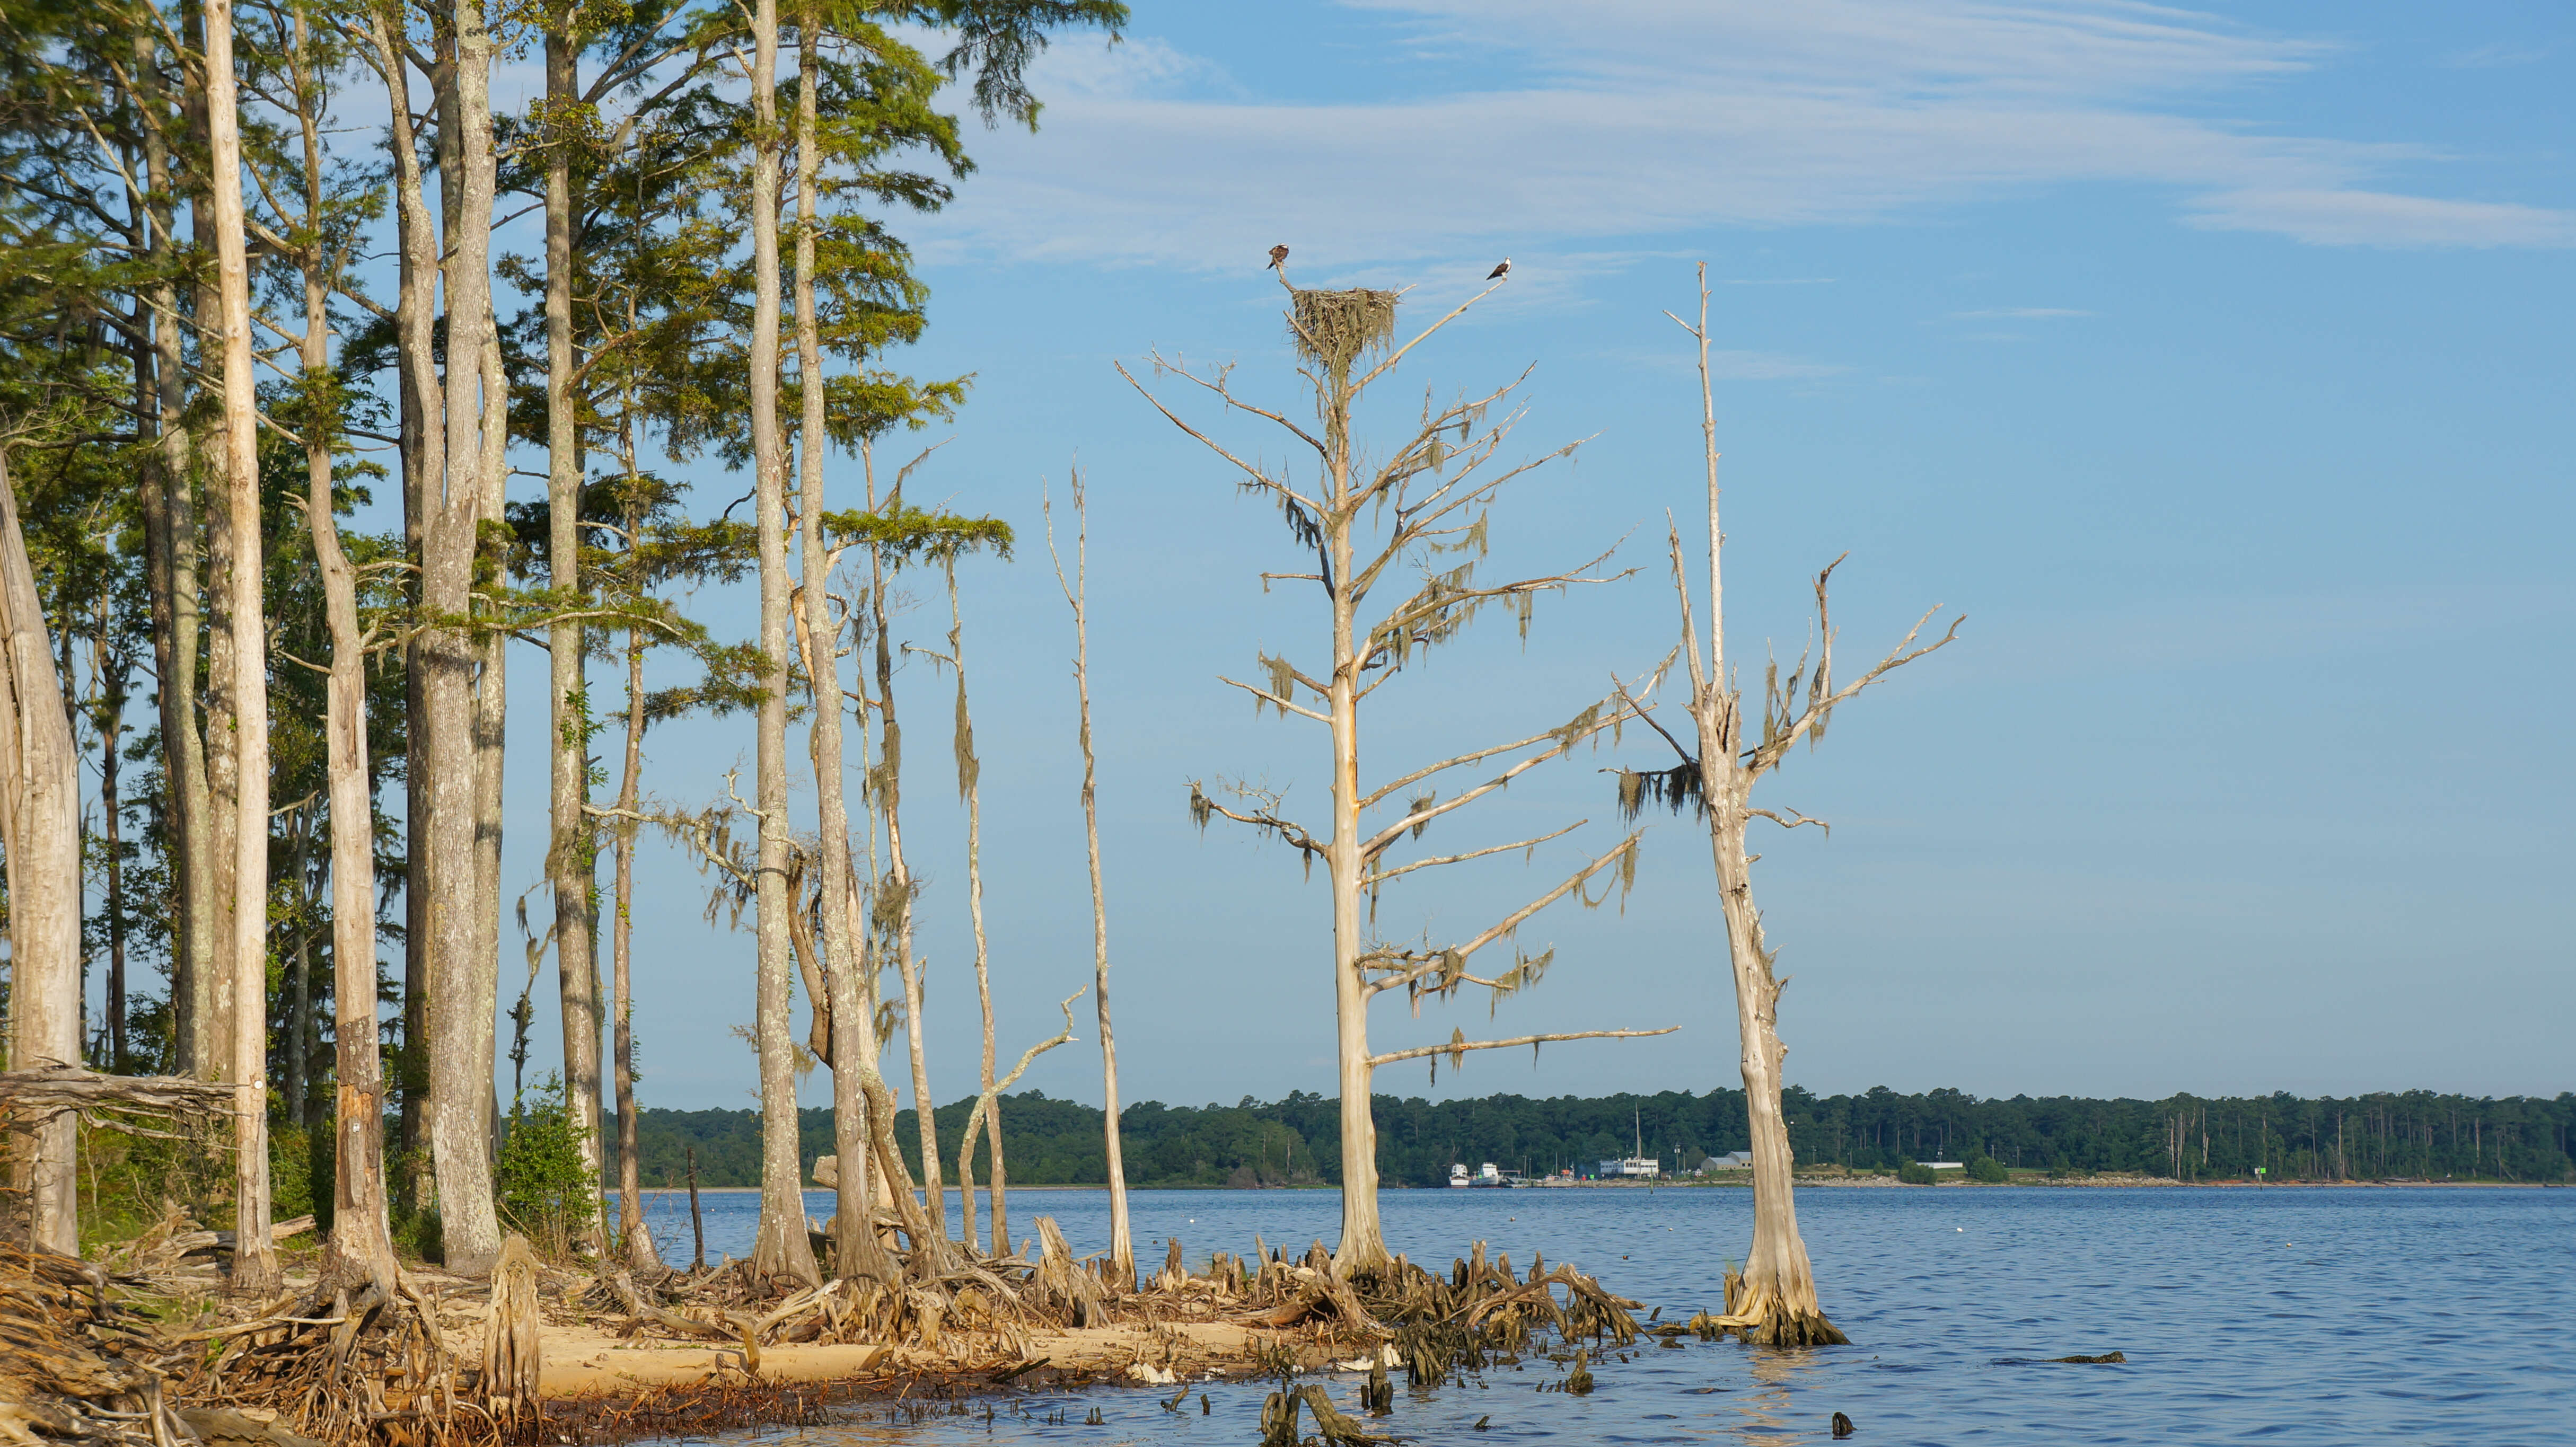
15, 1218, 1638, 1447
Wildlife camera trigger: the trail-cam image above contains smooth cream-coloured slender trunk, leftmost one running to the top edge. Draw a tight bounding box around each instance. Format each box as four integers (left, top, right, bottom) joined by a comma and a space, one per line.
206, 0, 281, 1295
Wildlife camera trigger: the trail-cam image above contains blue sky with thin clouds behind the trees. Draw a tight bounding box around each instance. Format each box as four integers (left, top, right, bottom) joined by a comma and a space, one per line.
453, 0, 2576, 1107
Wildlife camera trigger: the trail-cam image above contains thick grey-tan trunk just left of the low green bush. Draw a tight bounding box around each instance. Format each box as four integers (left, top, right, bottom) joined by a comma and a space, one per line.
420, 0, 503, 1275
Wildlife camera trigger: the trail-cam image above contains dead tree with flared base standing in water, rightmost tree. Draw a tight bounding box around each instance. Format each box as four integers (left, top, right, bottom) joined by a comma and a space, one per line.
1617, 265, 1963, 1347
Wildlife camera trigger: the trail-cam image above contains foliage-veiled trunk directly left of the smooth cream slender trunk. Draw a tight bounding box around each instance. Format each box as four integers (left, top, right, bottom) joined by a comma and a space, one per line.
134, 36, 214, 1076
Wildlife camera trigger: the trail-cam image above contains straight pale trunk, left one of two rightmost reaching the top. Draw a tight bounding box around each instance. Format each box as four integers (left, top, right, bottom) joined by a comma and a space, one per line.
750, 0, 822, 1282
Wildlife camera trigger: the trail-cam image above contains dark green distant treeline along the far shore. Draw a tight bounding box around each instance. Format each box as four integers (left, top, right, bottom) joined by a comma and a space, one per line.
608, 1087, 2576, 1187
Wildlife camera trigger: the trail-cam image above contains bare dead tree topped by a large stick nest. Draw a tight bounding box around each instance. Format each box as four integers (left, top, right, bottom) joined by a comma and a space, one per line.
1118, 268, 1672, 1277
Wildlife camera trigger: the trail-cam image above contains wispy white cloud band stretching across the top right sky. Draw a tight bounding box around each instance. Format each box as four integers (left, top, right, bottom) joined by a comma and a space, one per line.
922, 0, 2568, 266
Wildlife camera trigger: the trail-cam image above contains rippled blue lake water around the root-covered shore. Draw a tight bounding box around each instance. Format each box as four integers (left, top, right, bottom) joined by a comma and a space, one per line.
608, 1187, 2576, 1447
